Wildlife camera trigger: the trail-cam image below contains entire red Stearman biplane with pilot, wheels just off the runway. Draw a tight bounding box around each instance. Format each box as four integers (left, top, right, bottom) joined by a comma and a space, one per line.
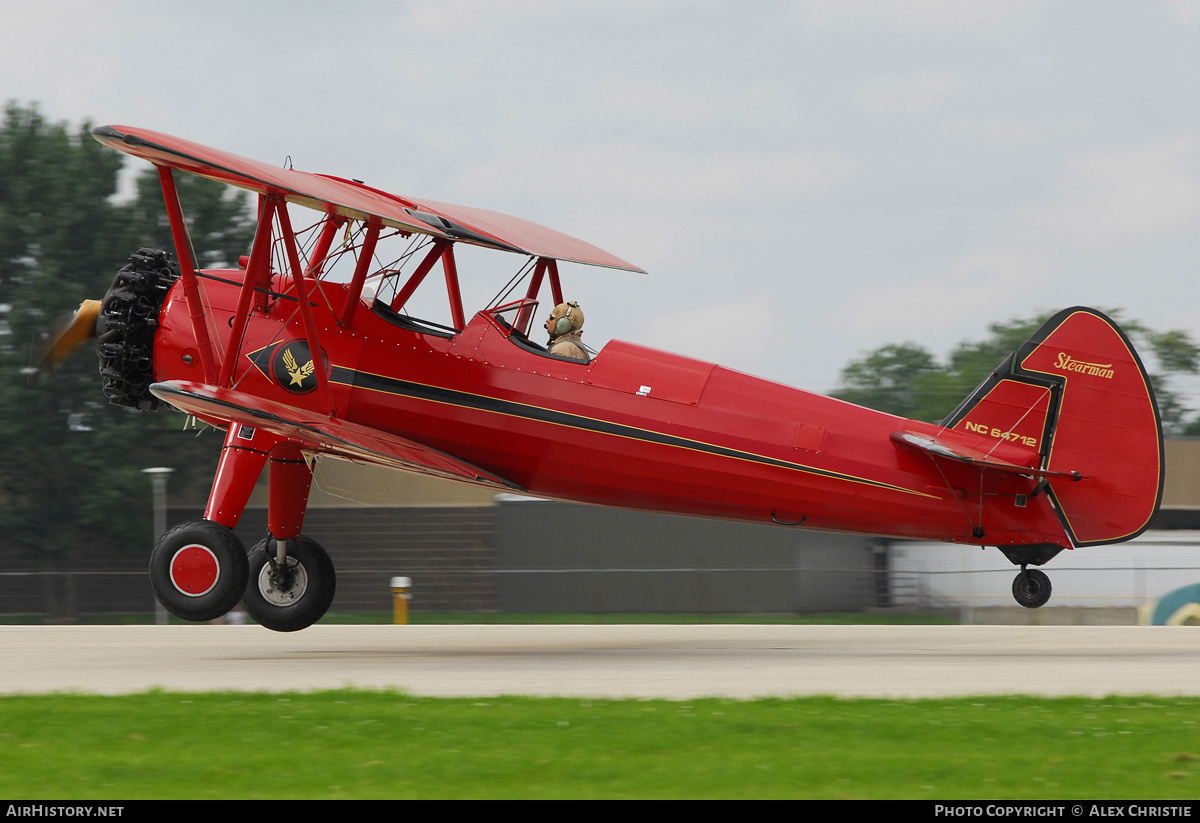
49, 126, 1163, 631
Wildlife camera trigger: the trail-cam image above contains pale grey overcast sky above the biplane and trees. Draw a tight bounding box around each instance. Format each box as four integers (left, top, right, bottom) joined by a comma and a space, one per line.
0, 0, 1200, 405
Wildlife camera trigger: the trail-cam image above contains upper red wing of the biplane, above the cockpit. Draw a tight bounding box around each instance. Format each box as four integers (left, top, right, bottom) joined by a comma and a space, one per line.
91, 126, 644, 274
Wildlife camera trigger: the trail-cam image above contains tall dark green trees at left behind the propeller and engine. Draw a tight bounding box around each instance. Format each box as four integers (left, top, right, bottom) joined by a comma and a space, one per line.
0, 102, 253, 587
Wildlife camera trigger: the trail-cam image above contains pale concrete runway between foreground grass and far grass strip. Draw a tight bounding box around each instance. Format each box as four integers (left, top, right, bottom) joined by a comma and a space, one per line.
0, 625, 1200, 699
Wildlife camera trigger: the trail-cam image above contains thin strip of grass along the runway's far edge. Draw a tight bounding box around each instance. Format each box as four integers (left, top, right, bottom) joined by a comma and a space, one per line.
0, 612, 958, 625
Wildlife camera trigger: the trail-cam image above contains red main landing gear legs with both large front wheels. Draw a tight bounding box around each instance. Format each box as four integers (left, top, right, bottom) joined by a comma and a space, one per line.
150, 423, 336, 631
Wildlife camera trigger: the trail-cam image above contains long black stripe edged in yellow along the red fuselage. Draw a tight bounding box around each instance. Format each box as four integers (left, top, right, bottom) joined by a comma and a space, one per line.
331, 366, 934, 497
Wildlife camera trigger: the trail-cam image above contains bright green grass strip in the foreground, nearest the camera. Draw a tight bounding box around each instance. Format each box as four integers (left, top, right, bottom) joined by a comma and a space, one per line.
0, 691, 1200, 800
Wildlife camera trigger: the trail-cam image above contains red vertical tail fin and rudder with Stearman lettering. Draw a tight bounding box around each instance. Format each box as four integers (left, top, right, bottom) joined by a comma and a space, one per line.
943, 307, 1163, 546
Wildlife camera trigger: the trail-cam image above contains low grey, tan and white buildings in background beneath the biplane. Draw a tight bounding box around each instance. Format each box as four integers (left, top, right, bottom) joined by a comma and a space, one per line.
9, 439, 1200, 614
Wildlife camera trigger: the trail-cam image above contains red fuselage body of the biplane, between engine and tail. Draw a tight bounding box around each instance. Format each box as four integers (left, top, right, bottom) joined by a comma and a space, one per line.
154, 270, 1070, 554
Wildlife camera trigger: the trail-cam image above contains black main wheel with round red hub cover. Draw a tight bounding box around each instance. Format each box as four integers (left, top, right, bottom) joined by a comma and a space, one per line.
150, 519, 250, 621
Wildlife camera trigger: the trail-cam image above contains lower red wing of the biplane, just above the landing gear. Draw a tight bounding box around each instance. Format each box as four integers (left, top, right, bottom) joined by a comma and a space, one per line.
150, 380, 524, 492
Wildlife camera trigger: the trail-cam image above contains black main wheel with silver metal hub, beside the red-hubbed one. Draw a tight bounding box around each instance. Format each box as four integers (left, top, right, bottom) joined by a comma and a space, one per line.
244, 535, 337, 631
